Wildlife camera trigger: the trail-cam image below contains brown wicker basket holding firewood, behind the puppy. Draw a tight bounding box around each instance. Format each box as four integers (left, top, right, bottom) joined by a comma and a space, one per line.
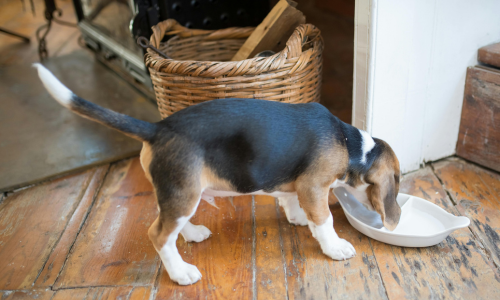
145, 20, 323, 118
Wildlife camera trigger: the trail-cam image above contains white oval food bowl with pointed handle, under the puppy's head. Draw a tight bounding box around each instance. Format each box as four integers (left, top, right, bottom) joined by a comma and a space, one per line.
333, 189, 470, 247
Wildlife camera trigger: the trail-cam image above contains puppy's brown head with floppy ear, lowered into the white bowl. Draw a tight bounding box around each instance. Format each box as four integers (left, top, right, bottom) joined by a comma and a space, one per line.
364, 139, 401, 231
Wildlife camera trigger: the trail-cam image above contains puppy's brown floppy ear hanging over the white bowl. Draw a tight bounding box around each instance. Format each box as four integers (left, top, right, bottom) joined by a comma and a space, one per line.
366, 172, 401, 231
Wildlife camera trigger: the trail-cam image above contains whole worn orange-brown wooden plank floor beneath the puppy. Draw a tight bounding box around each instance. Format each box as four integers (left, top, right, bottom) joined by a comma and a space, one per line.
0, 158, 500, 300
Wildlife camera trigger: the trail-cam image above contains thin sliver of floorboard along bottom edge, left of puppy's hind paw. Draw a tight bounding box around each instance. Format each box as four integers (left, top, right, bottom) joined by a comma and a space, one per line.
52, 286, 151, 300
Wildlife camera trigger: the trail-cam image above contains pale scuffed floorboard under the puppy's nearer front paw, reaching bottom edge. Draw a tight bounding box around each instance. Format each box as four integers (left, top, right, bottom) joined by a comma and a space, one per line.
279, 195, 387, 299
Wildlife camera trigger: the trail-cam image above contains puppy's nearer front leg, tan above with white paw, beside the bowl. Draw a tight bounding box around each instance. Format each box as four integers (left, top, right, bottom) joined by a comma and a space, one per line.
297, 185, 356, 260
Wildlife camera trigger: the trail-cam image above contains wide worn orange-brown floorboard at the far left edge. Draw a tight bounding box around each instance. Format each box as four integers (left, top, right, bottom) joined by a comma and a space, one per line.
0, 169, 96, 290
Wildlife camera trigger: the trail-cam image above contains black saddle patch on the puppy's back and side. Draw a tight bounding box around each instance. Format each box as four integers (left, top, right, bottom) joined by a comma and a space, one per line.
155, 99, 342, 193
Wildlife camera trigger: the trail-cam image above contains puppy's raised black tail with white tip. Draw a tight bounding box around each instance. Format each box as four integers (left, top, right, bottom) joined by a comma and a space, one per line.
33, 63, 157, 141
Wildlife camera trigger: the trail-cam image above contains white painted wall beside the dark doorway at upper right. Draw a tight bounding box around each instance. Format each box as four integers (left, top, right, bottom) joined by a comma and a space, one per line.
353, 0, 500, 172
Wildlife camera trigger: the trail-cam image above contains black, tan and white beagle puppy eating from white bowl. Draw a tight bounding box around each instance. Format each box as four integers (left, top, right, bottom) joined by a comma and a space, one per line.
34, 64, 401, 285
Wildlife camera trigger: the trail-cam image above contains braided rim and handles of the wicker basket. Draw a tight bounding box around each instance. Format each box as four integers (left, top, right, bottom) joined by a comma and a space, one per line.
144, 19, 323, 78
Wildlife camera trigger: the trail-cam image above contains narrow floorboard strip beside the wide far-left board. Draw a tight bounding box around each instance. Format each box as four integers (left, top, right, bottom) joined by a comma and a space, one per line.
34, 165, 109, 288
